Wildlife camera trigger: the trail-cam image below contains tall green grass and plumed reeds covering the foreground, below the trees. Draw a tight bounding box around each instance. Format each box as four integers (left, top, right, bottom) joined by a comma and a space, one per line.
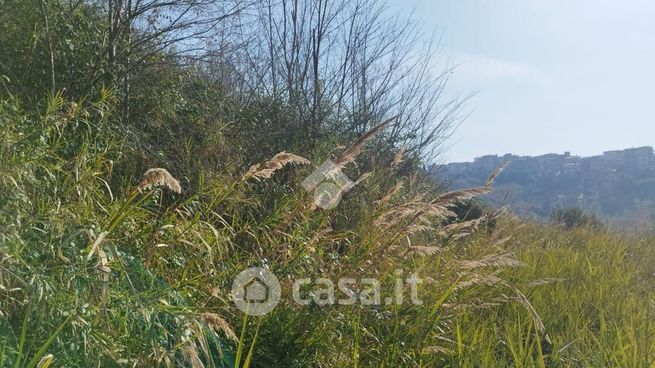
0, 95, 655, 367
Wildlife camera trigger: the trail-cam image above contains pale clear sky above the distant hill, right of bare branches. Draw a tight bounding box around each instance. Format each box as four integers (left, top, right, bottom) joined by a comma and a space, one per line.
390, 0, 655, 162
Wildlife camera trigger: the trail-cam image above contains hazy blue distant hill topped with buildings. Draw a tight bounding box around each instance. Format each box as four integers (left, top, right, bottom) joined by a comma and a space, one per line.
431, 147, 655, 225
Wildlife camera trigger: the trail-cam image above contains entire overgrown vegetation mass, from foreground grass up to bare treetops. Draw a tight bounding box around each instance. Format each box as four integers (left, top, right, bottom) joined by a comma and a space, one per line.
0, 0, 655, 368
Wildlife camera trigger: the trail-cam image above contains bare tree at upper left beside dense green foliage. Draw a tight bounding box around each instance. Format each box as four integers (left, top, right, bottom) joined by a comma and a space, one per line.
86, 0, 252, 118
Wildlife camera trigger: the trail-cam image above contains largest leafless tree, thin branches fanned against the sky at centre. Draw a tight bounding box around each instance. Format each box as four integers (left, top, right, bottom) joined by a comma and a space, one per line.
217, 0, 466, 158
